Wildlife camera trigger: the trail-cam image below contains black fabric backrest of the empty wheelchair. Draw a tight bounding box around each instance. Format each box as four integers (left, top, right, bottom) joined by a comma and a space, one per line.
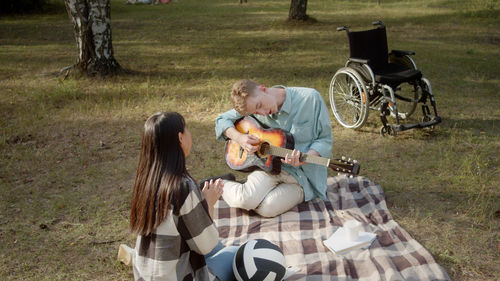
347, 27, 389, 70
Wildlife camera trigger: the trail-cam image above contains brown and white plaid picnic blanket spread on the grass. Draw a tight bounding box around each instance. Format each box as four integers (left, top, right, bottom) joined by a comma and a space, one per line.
215, 176, 450, 280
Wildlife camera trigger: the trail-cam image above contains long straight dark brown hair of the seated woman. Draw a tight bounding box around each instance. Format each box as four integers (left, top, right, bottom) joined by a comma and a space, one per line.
130, 112, 189, 235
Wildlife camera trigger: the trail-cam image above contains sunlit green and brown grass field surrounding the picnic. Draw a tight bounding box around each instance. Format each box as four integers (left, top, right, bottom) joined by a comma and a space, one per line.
0, 0, 500, 280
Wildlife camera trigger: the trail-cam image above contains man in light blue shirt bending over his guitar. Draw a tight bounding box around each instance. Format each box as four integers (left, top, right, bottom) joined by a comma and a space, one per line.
215, 80, 332, 217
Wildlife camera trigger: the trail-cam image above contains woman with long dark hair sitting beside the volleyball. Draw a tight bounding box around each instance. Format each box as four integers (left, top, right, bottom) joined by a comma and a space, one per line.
119, 112, 238, 281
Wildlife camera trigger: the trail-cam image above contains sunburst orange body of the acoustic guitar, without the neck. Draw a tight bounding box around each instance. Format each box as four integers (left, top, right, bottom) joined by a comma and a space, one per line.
225, 116, 295, 174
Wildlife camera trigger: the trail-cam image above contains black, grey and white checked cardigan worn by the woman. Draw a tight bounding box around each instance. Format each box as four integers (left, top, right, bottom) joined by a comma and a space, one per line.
133, 178, 219, 281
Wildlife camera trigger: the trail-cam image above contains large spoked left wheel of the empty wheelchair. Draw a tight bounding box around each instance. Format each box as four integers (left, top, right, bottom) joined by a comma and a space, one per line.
329, 67, 369, 129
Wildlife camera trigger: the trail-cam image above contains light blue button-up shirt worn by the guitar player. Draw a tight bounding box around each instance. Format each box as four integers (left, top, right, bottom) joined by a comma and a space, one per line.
215, 87, 333, 201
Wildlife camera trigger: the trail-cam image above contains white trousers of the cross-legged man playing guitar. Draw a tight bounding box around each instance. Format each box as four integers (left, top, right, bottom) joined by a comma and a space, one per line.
222, 170, 304, 217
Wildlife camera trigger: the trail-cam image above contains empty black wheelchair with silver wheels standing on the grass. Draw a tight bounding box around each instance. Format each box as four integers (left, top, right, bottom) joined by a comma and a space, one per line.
329, 21, 441, 136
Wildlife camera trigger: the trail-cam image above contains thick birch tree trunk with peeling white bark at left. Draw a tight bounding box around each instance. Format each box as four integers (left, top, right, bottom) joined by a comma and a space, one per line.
64, 0, 121, 76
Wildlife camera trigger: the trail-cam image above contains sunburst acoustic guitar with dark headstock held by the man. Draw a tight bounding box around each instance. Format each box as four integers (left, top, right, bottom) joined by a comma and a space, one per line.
225, 116, 360, 175
